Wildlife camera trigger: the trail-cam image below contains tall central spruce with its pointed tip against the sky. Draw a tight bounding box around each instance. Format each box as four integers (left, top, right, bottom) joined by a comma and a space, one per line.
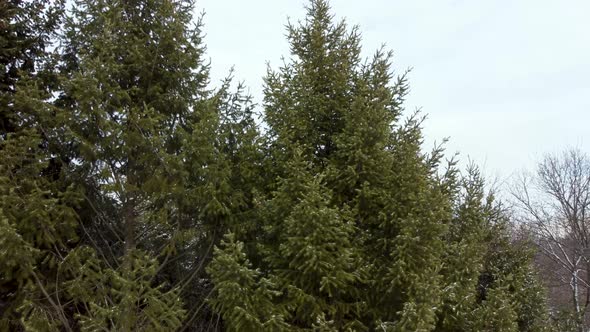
213, 1, 450, 330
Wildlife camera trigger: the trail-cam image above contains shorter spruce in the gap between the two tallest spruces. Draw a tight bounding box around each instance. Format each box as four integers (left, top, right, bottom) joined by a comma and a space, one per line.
177, 76, 263, 329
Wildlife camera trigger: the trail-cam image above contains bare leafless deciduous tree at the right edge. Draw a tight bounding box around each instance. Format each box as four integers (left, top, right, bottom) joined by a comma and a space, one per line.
512, 149, 590, 332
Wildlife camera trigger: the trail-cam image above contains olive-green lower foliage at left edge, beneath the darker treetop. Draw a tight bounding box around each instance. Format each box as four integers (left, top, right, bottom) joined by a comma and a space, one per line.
0, 86, 81, 329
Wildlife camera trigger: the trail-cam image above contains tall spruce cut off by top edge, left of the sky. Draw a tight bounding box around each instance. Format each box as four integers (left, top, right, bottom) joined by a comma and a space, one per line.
59, 1, 208, 260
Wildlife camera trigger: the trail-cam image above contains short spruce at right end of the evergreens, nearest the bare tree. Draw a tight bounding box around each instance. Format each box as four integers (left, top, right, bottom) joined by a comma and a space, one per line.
436, 165, 550, 331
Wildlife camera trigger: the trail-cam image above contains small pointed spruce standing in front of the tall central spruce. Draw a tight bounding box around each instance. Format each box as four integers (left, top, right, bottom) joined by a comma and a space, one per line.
262, 152, 364, 330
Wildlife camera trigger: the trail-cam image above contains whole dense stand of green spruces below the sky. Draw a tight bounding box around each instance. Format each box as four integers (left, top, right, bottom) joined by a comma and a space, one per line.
0, 0, 550, 332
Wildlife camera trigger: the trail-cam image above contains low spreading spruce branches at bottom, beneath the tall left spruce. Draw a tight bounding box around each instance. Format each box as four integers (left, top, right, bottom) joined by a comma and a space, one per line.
62, 247, 185, 331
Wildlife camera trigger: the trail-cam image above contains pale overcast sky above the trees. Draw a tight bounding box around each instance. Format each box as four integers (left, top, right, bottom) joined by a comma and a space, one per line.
197, 0, 590, 180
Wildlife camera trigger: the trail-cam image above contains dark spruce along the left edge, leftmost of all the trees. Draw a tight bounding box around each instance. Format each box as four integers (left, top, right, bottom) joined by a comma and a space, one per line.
0, 1, 85, 331
